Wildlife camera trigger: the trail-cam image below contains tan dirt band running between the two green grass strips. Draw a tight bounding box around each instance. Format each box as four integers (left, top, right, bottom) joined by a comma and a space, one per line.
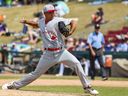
0, 79, 128, 87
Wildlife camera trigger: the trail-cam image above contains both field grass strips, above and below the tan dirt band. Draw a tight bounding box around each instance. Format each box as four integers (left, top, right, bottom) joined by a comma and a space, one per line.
0, 74, 128, 96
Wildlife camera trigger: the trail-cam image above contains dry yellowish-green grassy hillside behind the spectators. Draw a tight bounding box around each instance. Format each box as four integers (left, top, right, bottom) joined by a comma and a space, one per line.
0, 2, 128, 44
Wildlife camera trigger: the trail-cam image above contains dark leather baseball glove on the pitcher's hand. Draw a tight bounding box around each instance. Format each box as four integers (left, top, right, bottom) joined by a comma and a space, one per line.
58, 21, 69, 37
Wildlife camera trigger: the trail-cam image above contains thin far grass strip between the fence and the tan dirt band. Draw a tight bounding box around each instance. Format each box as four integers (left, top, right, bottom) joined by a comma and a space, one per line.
0, 74, 128, 81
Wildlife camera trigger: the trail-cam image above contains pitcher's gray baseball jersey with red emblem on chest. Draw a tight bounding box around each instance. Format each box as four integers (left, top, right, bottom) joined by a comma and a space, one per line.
39, 17, 71, 48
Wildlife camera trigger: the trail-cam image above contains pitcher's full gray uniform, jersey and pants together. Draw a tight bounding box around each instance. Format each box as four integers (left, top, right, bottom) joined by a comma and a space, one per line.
11, 17, 90, 88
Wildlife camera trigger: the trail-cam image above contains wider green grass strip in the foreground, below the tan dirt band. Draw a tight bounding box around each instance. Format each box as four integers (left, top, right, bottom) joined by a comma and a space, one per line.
21, 86, 128, 96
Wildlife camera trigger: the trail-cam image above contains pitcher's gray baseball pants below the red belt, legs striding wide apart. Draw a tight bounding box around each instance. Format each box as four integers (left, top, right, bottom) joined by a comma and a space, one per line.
13, 49, 90, 89
